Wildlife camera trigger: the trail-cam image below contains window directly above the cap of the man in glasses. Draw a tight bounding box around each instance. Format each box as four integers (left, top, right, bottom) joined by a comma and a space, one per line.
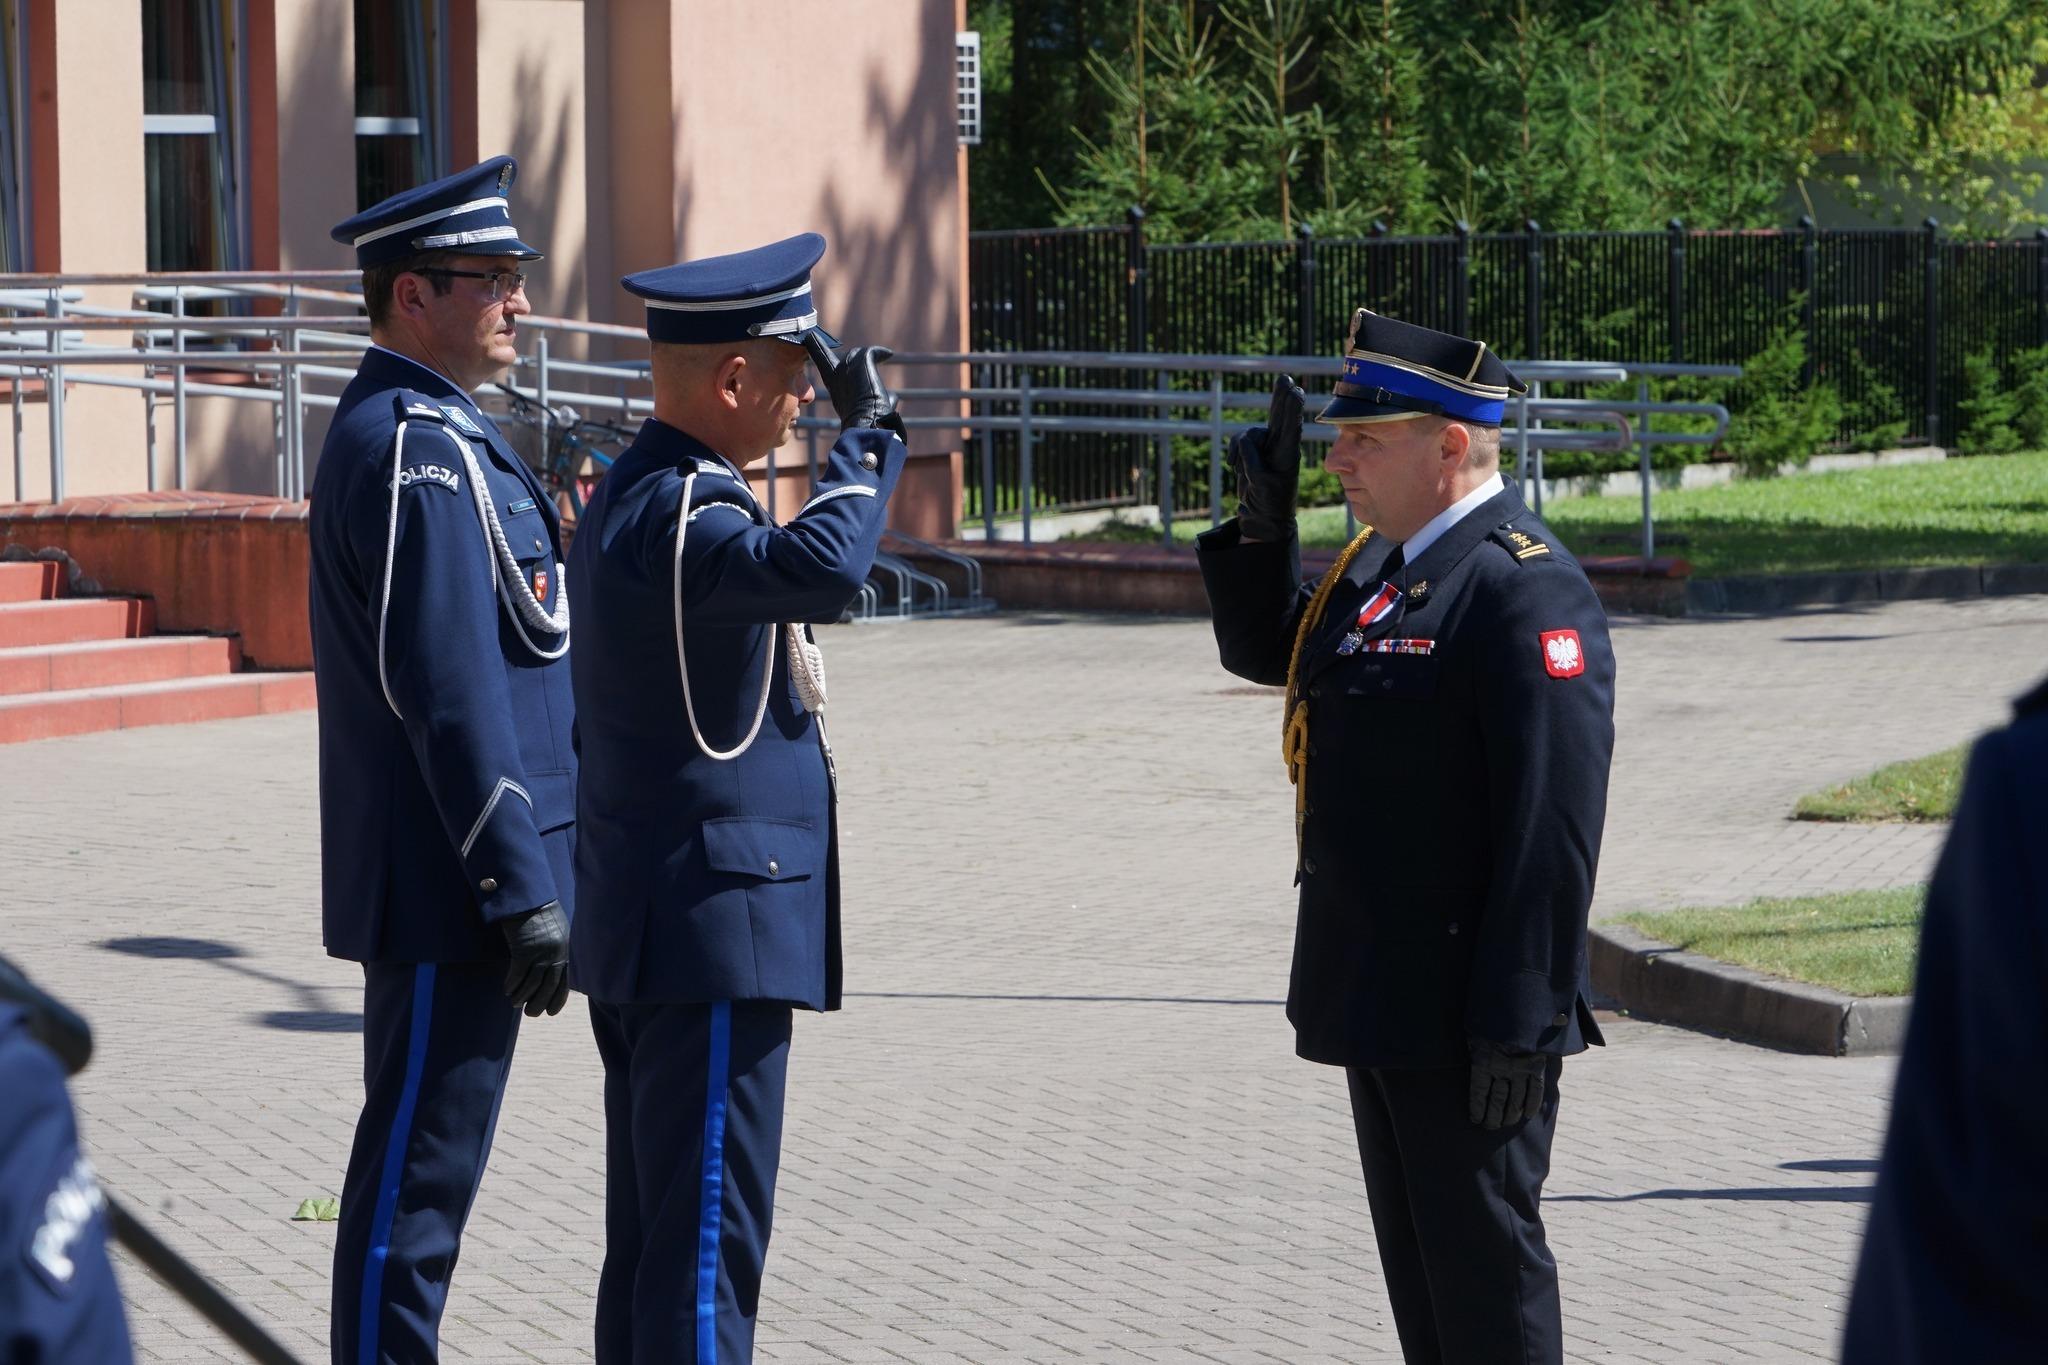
356, 0, 446, 209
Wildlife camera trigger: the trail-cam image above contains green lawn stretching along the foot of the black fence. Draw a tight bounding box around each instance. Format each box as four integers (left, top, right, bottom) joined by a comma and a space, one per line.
1087, 452, 2048, 577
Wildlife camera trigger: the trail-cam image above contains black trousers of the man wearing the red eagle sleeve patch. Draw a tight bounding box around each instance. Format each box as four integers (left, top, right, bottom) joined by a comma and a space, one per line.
1343, 1058, 1565, 1365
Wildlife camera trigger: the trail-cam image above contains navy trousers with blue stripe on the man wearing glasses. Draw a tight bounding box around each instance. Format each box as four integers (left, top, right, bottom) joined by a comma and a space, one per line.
330, 962, 520, 1365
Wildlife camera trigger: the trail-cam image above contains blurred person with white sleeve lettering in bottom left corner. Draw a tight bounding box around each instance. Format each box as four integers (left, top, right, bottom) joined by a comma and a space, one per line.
0, 978, 135, 1365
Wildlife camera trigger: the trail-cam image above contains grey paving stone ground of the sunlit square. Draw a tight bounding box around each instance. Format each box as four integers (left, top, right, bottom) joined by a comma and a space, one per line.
0, 598, 2048, 1363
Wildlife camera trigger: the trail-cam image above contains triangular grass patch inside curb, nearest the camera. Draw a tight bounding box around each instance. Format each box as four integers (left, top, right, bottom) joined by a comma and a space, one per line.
1622, 886, 1927, 997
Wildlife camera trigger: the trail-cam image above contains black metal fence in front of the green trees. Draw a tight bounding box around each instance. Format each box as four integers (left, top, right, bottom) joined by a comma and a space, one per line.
969, 213, 2048, 454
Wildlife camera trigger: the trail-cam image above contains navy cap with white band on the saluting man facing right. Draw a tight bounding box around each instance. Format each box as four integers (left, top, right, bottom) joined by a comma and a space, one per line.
618, 231, 840, 346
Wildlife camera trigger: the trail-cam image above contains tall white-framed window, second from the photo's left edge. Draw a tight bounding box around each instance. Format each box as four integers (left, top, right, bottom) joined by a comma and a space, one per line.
141, 0, 248, 270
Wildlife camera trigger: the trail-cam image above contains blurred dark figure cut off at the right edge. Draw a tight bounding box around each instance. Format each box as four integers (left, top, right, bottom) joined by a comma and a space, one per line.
1841, 684, 2048, 1365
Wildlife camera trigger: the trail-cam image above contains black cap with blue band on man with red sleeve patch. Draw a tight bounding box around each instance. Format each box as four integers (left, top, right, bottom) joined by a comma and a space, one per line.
1321, 309, 1526, 426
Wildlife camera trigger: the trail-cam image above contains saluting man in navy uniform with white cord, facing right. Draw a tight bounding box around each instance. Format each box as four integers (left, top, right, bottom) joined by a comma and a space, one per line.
569, 233, 905, 1365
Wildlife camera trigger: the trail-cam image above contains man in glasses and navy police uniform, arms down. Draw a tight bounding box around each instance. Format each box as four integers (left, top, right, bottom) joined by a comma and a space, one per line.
311, 156, 575, 1365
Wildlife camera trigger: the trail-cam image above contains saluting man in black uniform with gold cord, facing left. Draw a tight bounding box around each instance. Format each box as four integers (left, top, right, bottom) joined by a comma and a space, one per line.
1200, 309, 1614, 1365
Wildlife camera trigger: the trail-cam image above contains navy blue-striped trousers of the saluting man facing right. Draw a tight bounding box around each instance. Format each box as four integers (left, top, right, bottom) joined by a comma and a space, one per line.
590, 1001, 791, 1365
